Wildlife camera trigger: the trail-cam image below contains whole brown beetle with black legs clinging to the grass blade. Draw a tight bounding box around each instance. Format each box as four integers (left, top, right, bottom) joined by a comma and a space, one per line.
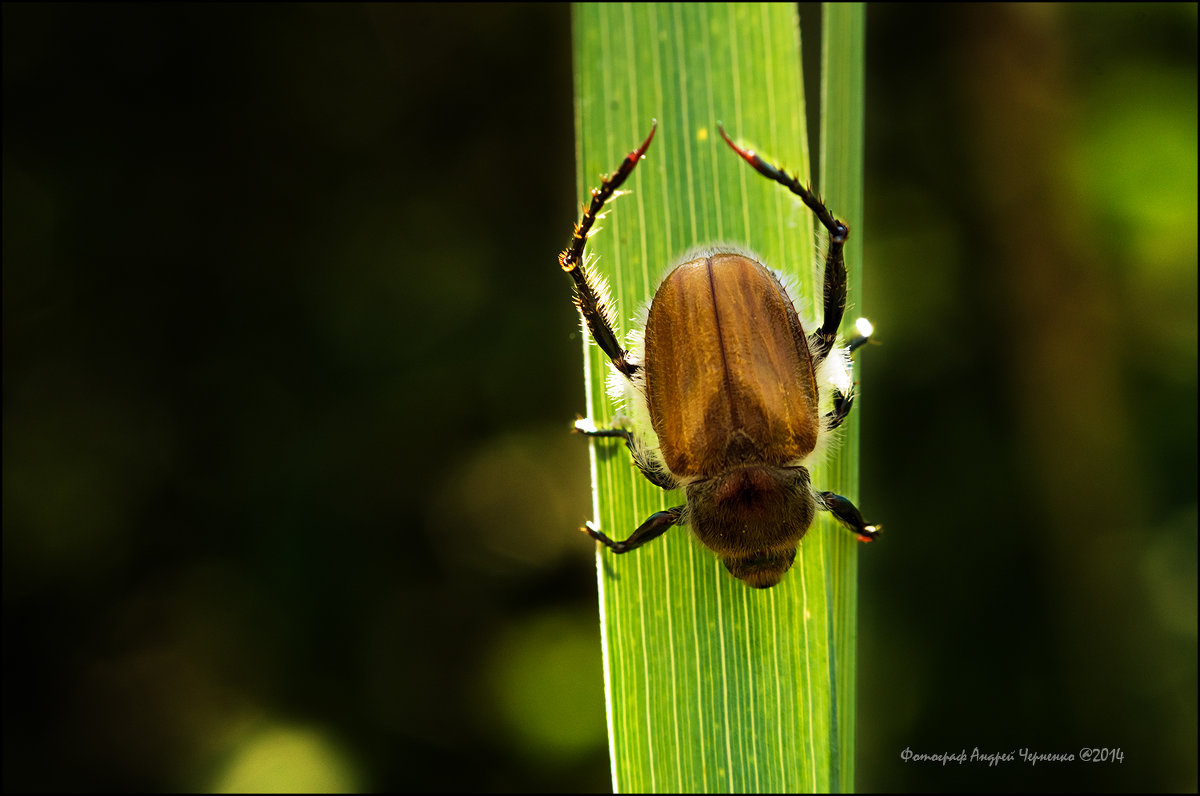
558, 121, 880, 588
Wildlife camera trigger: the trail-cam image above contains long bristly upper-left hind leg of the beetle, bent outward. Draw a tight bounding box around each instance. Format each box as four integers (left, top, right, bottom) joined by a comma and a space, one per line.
558, 120, 659, 376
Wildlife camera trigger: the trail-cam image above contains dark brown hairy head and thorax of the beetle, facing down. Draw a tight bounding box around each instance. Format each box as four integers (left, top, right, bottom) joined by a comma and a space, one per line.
688, 466, 816, 588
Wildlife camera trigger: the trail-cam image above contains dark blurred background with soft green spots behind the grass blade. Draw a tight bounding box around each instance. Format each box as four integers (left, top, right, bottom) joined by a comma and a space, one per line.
2, 4, 1198, 791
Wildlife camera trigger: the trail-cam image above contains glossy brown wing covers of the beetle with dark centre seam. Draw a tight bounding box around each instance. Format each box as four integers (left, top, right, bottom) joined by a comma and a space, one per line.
646, 253, 820, 477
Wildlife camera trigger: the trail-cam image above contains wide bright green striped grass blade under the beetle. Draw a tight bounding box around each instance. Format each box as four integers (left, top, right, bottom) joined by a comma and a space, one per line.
574, 4, 862, 792
